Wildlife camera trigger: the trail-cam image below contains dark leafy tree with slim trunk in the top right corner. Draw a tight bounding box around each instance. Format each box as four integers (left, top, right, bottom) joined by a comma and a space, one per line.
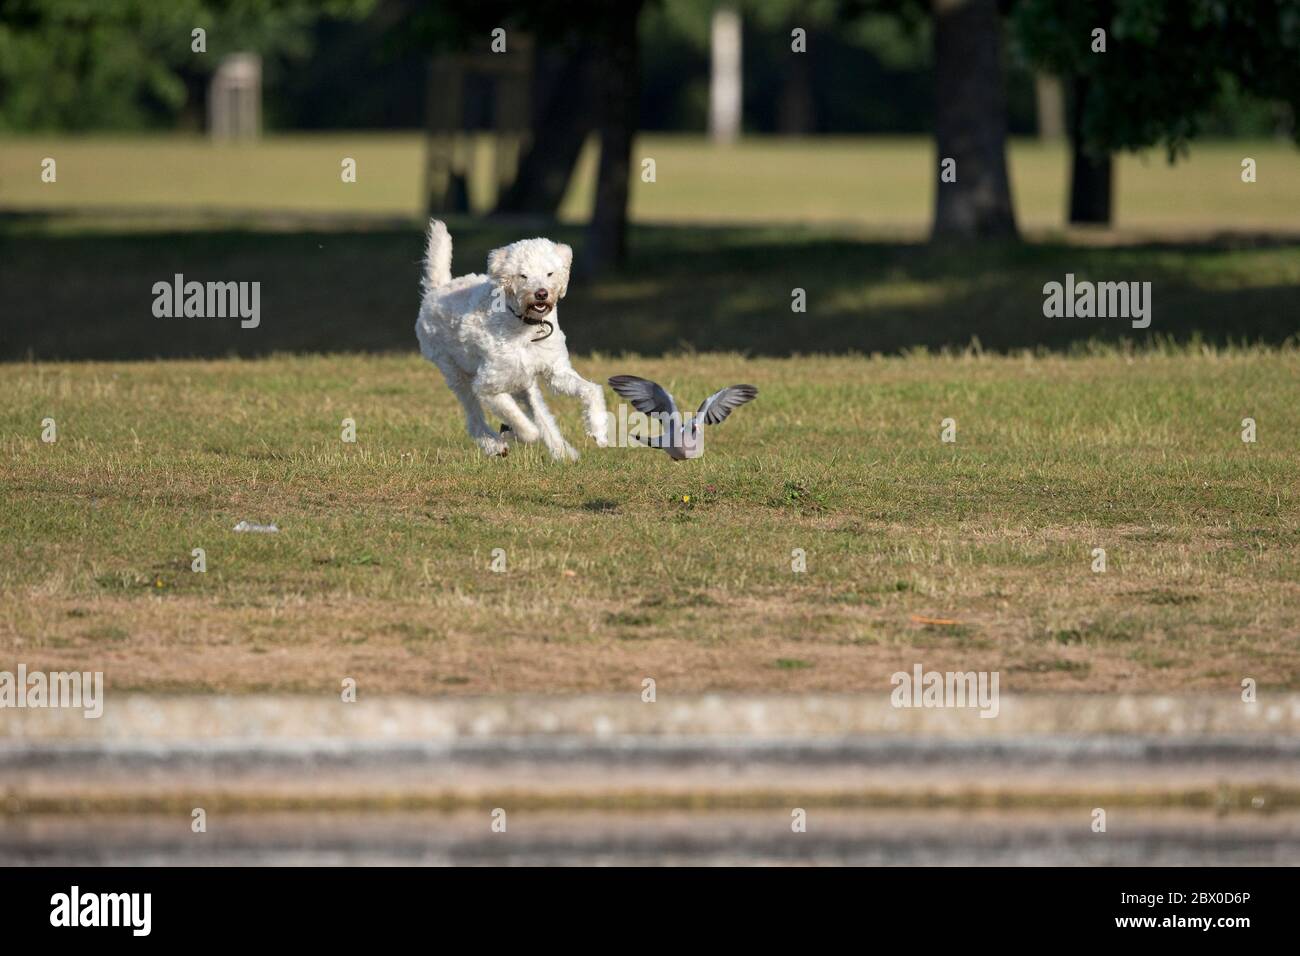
1013, 0, 1300, 222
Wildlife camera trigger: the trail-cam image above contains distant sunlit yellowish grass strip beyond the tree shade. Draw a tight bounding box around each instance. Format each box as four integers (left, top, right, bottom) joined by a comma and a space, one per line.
0, 133, 1300, 237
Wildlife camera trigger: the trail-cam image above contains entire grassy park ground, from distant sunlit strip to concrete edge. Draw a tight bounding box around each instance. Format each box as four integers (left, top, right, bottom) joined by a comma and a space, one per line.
0, 135, 1300, 695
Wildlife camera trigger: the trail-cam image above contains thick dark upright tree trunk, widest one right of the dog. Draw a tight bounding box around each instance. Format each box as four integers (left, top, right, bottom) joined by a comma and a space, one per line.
932, 0, 1017, 239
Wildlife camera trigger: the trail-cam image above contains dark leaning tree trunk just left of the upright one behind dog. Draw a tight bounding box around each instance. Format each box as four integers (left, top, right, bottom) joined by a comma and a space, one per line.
495, 39, 597, 217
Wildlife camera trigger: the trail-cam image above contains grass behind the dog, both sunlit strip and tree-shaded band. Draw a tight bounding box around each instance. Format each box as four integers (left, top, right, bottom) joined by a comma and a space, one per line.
0, 134, 1300, 359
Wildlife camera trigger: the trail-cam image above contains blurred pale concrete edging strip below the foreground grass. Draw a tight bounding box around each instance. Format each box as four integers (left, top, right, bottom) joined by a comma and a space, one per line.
0, 695, 1300, 816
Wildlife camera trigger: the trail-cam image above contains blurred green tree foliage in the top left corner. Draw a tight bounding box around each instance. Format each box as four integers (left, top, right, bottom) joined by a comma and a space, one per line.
0, 0, 373, 130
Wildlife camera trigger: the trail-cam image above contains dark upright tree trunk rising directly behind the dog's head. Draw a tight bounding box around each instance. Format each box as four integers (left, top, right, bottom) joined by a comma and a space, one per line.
582, 0, 642, 276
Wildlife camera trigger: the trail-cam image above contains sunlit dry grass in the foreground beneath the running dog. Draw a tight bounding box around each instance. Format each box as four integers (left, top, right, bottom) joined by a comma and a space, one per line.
0, 349, 1300, 695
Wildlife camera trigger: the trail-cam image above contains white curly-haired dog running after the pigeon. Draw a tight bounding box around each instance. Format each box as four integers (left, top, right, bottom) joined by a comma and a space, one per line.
415, 220, 608, 459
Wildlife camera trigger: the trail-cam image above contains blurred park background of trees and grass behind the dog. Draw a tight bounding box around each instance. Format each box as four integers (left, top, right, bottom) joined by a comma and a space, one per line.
0, 0, 1300, 359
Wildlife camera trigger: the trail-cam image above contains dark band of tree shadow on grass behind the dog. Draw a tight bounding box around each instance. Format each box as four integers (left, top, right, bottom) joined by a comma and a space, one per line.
0, 216, 1300, 360
